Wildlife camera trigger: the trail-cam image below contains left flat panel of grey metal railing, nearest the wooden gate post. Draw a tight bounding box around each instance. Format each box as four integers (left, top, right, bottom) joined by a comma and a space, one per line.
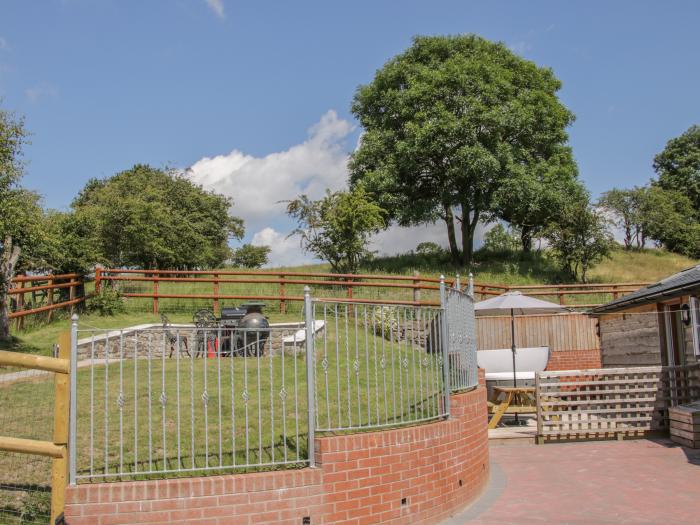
74, 324, 308, 482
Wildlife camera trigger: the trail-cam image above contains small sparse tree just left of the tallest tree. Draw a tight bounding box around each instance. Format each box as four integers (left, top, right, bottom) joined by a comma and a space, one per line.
287, 188, 386, 273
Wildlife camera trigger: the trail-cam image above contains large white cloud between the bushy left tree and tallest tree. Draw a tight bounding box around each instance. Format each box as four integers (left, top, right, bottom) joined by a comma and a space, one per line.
187, 111, 353, 231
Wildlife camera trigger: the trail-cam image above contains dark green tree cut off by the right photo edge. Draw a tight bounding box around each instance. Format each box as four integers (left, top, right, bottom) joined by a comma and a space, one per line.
652, 126, 700, 210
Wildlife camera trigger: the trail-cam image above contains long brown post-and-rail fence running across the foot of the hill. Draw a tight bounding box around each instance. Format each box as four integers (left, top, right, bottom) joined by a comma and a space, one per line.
95, 269, 644, 313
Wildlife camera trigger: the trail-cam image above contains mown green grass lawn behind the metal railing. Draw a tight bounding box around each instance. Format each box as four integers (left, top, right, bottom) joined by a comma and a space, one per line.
0, 308, 442, 486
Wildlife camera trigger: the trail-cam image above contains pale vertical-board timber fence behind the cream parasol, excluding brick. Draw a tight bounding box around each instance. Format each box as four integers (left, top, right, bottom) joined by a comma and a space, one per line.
476, 313, 600, 352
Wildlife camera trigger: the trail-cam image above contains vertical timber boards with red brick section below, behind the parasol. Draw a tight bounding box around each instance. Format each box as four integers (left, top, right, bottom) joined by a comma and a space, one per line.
477, 313, 601, 370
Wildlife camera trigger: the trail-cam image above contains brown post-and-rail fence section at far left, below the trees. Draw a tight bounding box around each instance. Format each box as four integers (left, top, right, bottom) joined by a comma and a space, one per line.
8, 273, 85, 329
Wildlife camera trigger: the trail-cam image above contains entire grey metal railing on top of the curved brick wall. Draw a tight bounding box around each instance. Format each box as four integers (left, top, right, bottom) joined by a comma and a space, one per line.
70, 281, 476, 483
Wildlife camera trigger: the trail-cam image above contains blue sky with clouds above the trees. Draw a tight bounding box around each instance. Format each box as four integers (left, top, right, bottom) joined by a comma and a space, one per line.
0, 0, 700, 262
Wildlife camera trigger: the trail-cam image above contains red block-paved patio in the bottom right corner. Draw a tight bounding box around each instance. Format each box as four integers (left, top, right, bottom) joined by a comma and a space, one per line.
443, 439, 700, 525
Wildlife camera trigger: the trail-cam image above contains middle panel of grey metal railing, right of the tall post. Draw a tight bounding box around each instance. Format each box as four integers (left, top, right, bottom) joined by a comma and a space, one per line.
313, 299, 447, 431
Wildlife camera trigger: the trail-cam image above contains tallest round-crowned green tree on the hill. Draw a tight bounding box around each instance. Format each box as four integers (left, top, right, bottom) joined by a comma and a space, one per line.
350, 35, 574, 263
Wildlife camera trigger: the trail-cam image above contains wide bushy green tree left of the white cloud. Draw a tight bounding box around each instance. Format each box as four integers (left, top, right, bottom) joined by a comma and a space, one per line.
72, 164, 243, 269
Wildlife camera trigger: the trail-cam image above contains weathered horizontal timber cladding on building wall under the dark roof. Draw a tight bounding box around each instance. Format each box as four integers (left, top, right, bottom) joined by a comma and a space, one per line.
600, 305, 661, 368
